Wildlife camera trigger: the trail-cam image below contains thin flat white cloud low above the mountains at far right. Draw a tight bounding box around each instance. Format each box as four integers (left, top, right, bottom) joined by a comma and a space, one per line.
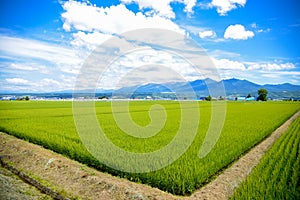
247, 63, 296, 71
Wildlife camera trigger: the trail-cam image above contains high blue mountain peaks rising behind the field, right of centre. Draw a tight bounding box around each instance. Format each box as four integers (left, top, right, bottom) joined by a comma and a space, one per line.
115, 78, 300, 98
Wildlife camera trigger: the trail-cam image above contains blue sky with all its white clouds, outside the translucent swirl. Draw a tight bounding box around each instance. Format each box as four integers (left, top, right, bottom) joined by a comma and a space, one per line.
0, 0, 300, 92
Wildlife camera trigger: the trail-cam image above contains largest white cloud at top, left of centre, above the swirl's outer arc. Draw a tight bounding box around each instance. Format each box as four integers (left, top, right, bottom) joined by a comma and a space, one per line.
61, 0, 185, 50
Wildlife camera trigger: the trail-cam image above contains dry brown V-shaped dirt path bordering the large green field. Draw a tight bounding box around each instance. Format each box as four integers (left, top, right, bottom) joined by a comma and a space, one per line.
0, 111, 300, 200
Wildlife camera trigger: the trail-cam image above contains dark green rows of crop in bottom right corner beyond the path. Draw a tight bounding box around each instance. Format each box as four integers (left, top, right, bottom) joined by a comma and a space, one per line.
232, 117, 300, 200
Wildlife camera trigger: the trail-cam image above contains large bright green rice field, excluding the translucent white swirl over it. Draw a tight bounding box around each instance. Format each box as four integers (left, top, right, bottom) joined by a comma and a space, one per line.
0, 101, 300, 195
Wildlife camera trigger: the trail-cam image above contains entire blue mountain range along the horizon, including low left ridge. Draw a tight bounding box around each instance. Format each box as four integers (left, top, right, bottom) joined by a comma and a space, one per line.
0, 78, 300, 100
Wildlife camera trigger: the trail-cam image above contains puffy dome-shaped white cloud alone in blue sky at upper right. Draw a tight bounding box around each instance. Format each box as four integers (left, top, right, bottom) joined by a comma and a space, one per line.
224, 24, 254, 40
